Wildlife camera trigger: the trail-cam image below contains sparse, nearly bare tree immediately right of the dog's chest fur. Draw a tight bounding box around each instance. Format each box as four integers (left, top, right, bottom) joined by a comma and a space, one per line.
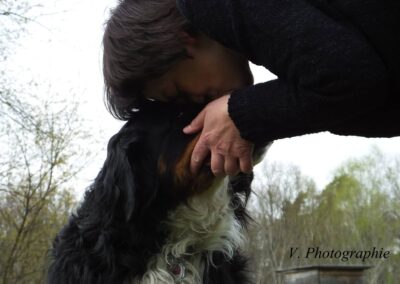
247, 163, 315, 284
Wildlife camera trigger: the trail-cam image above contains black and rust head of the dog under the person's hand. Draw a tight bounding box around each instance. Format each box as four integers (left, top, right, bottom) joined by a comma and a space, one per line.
92, 101, 217, 220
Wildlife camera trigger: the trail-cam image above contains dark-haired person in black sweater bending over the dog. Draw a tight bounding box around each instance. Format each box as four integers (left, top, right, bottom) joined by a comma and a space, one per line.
103, 0, 400, 178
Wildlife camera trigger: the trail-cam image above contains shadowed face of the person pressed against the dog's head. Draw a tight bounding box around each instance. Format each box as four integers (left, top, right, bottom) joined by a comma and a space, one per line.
144, 35, 253, 103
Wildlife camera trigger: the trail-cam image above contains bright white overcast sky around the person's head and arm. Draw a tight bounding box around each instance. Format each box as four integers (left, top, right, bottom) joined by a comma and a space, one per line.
5, 0, 400, 193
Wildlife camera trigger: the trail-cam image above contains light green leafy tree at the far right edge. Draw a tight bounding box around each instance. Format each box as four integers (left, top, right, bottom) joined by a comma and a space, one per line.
318, 148, 400, 283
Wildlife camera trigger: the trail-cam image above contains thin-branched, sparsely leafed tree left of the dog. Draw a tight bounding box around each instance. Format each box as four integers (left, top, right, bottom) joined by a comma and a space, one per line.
0, 0, 91, 284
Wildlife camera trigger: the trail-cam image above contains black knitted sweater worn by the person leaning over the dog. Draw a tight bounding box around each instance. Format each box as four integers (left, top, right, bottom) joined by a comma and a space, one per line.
177, 0, 400, 143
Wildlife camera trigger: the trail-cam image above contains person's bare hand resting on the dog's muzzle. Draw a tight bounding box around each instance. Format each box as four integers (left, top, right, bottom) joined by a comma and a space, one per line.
183, 95, 254, 176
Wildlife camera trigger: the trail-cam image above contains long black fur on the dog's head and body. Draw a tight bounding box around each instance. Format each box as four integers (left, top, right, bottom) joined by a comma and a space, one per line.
48, 101, 260, 284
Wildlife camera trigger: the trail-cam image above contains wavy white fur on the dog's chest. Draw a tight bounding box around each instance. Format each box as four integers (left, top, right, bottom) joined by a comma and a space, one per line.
133, 180, 243, 284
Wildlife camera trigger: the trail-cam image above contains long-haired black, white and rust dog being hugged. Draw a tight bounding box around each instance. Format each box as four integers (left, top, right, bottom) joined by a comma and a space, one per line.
48, 101, 268, 284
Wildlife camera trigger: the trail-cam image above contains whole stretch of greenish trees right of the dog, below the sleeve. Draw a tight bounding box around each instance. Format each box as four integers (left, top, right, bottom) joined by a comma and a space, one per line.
248, 152, 400, 284
